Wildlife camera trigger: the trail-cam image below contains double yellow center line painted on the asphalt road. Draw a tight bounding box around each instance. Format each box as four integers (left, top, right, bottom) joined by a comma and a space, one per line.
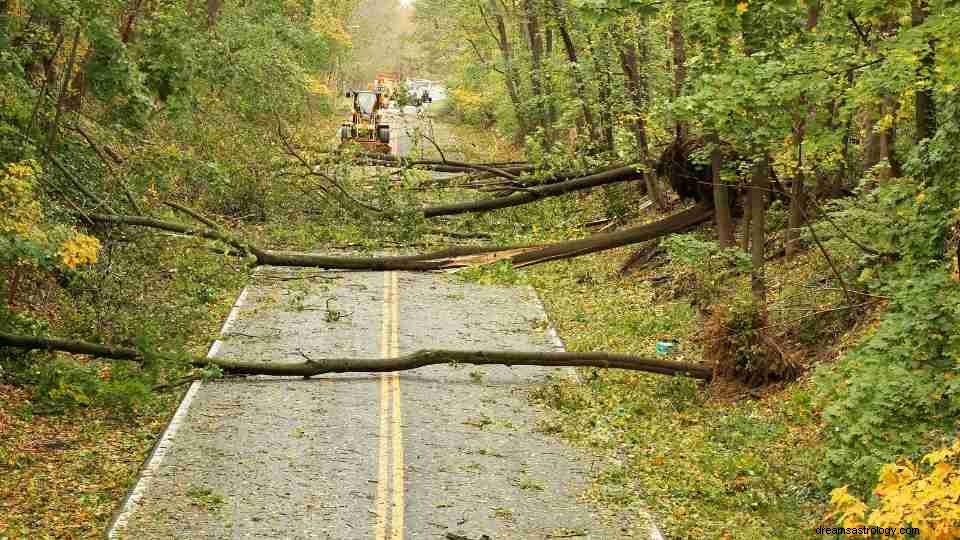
376, 272, 404, 540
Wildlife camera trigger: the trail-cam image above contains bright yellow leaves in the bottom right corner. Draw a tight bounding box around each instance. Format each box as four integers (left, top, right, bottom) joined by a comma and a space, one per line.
830, 439, 960, 540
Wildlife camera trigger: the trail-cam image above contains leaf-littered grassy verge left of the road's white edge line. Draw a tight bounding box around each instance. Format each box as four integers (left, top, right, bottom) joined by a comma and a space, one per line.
0, 237, 246, 540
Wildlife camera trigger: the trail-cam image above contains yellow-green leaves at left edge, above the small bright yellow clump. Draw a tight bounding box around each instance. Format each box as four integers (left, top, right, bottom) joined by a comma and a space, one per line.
0, 160, 45, 240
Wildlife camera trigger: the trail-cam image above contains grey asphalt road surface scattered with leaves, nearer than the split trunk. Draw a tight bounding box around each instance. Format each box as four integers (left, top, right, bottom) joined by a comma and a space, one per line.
108, 112, 651, 540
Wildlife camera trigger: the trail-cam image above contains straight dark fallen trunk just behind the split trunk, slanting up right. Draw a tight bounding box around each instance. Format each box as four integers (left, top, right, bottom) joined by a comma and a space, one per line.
423, 165, 643, 218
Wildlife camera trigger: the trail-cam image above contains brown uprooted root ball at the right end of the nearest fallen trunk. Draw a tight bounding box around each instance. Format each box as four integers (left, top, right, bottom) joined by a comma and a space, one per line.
702, 306, 801, 387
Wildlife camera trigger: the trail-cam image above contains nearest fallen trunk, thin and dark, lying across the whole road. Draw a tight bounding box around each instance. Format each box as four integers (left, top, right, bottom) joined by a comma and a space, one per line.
0, 333, 713, 380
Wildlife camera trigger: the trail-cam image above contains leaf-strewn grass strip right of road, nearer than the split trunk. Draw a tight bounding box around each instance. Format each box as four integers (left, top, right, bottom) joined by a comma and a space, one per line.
529, 250, 824, 540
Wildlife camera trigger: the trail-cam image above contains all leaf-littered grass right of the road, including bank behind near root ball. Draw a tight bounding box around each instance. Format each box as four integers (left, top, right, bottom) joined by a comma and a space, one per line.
432, 117, 872, 540
